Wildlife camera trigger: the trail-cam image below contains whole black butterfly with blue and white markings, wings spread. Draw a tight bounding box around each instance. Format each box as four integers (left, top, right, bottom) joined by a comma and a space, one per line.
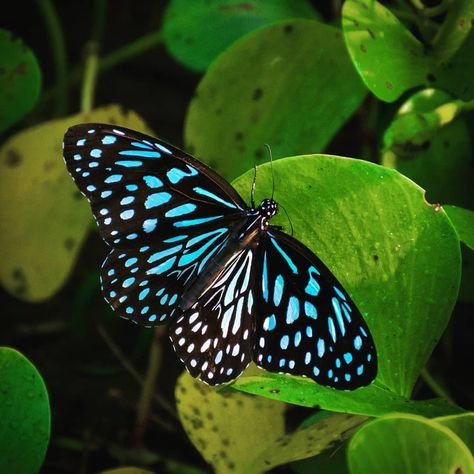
63, 124, 377, 390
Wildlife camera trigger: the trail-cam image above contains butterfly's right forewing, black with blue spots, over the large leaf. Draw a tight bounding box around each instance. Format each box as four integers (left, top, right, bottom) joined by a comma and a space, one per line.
253, 227, 377, 390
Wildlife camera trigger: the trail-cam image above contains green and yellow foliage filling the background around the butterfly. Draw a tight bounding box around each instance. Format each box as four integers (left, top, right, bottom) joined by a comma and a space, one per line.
0, 0, 474, 474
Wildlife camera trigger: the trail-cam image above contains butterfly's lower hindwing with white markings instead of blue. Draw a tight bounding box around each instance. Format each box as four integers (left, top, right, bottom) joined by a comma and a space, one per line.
169, 246, 255, 385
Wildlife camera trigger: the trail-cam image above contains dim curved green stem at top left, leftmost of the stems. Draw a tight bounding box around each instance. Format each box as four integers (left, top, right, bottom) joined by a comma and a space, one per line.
38, 0, 68, 117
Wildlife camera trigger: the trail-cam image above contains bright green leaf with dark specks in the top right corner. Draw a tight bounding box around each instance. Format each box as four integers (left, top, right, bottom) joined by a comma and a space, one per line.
342, 0, 474, 102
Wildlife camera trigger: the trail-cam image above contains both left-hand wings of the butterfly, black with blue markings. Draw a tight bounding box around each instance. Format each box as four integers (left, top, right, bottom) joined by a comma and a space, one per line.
64, 124, 247, 325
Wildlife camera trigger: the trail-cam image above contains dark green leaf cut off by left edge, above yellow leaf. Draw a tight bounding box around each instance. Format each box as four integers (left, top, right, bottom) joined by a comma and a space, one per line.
0, 29, 41, 133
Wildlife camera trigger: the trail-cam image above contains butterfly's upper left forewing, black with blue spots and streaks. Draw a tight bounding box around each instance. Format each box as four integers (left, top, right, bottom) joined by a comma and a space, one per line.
64, 124, 246, 249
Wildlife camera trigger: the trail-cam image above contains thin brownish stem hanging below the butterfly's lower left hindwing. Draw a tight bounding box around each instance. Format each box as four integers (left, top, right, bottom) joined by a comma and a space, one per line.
133, 326, 166, 448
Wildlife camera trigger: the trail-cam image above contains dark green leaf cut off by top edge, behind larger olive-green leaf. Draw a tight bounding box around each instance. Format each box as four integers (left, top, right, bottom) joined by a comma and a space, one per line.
163, 0, 318, 71
